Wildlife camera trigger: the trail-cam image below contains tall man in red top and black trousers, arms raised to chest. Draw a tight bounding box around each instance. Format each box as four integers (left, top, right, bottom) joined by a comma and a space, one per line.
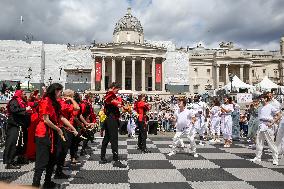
100, 82, 127, 168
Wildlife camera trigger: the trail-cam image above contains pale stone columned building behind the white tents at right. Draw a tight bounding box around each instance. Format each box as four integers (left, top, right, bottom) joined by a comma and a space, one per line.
186, 40, 284, 94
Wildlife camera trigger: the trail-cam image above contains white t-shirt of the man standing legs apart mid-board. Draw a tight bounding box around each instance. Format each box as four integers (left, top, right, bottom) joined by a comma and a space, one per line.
174, 109, 195, 131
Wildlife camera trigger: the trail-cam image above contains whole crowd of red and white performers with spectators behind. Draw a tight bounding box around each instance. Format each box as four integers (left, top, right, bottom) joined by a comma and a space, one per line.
0, 82, 284, 188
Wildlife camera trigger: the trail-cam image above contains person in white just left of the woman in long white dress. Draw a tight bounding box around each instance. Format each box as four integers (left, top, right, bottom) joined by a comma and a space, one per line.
210, 99, 221, 143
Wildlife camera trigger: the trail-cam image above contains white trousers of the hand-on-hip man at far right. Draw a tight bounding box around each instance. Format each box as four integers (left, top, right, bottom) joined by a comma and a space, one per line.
256, 129, 278, 160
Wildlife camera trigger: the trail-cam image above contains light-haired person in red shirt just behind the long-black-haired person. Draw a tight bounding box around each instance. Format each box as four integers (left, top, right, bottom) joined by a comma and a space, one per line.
54, 89, 80, 179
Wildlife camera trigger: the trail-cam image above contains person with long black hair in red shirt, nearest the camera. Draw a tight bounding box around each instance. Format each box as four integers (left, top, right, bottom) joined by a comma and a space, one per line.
32, 83, 77, 188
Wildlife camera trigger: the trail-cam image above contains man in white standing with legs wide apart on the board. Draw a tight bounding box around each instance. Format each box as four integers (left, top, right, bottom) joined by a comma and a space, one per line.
168, 98, 198, 157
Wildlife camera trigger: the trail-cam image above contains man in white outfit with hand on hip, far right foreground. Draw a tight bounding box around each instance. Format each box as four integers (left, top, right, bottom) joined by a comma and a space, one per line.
251, 94, 281, 165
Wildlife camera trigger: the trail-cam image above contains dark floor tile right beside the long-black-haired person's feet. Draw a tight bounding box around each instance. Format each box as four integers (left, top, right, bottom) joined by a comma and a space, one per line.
70, 170, 128, 184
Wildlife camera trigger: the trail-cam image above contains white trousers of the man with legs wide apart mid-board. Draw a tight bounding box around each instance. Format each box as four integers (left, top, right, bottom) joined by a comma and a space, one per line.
172, 127, 196, 153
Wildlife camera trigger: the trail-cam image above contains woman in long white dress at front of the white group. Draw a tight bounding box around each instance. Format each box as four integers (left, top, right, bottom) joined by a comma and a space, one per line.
221, 97, 234, 148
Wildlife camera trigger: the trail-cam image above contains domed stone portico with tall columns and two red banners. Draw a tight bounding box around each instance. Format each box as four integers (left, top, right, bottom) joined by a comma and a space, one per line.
90, 8, 167, 93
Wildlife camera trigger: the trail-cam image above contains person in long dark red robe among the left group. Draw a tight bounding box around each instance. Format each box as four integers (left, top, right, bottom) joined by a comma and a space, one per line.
25, 90, 40, 161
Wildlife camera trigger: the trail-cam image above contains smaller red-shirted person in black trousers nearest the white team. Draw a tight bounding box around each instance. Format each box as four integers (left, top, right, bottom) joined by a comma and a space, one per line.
134, 94, 151, 153
